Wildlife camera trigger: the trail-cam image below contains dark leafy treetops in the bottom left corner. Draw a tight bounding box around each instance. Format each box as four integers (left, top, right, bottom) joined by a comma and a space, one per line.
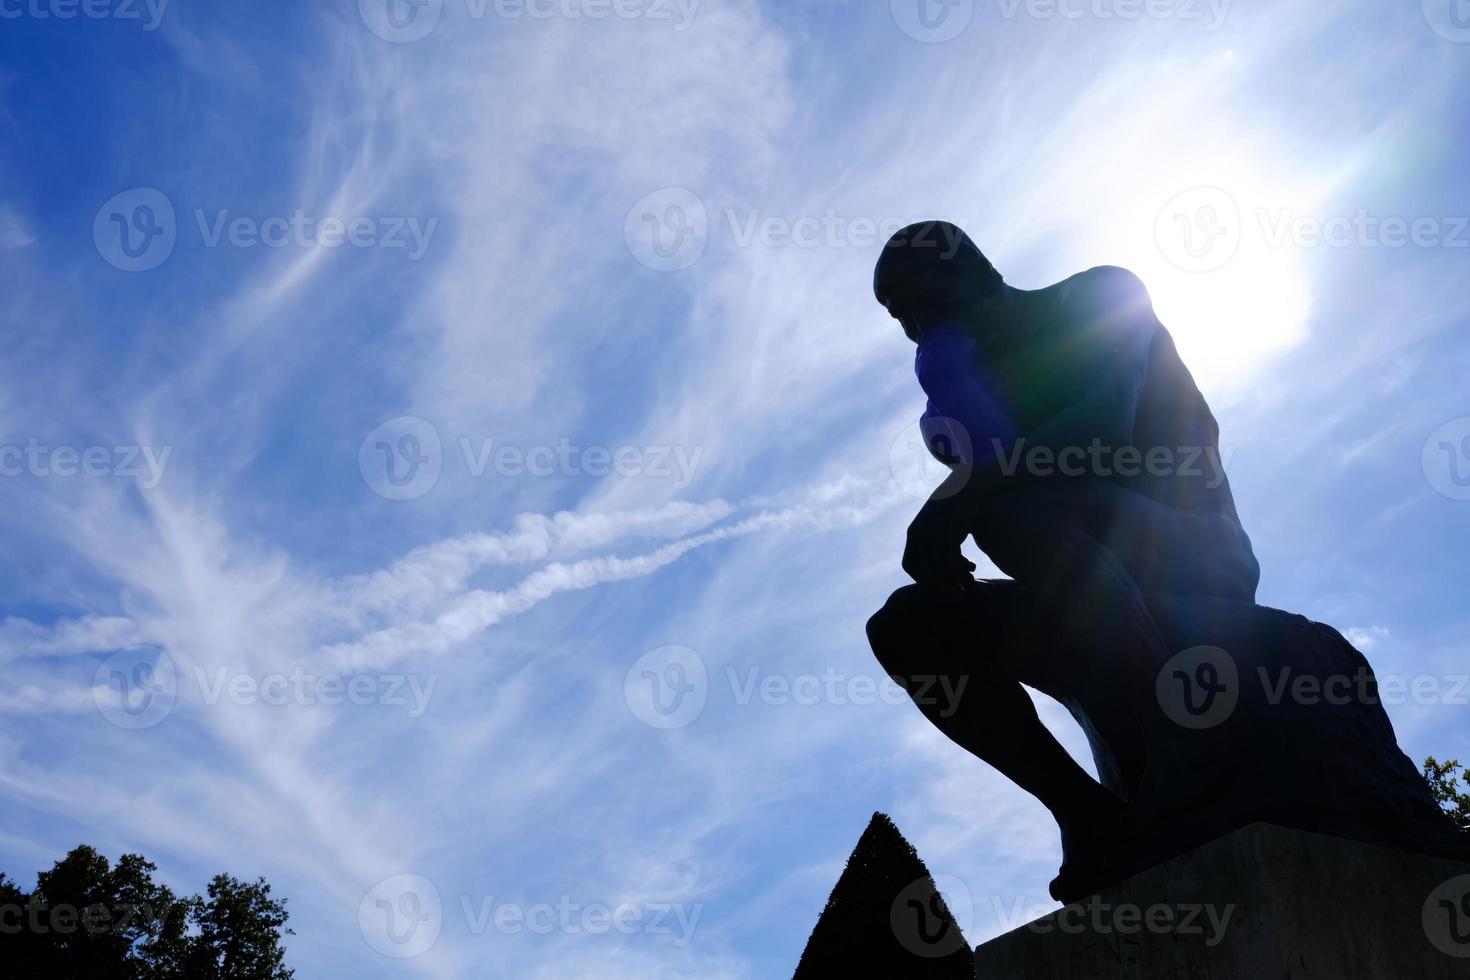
0, 845, 293, 980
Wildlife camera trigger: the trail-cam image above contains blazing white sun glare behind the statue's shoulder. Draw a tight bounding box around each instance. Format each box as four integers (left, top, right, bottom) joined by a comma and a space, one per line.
1028, 69, 1333, 394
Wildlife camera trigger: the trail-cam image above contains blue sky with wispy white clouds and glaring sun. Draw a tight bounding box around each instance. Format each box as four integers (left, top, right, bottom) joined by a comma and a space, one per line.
0, 0, 1470, 977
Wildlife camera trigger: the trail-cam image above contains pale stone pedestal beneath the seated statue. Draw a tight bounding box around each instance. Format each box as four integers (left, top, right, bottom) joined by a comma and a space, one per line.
975, 823, 1470, 980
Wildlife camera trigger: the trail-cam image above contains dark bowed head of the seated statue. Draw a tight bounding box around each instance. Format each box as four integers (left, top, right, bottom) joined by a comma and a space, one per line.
873, 222, 1004, 341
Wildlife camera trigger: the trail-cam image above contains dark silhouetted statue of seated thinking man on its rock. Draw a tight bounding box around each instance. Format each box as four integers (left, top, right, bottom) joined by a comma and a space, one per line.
867, 222, 1470, 901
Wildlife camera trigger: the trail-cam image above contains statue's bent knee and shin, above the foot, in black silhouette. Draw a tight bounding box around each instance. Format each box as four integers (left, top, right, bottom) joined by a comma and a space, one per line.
867, 582, 1116, 835
